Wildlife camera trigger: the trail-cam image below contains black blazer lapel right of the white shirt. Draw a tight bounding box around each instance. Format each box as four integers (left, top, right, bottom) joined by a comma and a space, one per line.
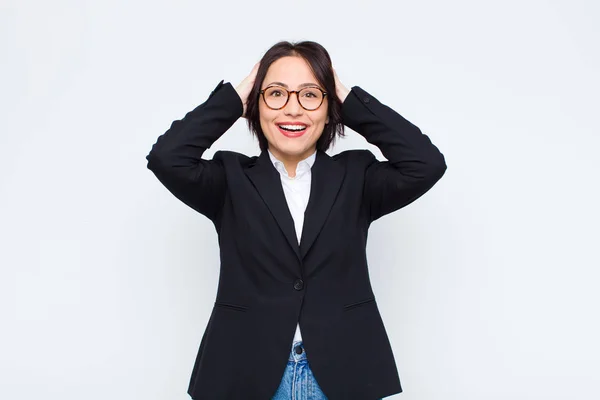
300, 151, 344, 258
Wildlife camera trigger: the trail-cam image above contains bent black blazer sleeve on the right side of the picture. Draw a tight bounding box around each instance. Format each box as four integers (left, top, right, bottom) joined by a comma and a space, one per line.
342, 86, 447, 221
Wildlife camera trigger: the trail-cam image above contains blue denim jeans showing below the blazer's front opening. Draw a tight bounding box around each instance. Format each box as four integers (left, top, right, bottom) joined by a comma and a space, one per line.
271, 342, 327, 400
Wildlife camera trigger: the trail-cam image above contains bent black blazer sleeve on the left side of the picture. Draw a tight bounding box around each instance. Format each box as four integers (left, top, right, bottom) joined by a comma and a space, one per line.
146, 81, 243, 221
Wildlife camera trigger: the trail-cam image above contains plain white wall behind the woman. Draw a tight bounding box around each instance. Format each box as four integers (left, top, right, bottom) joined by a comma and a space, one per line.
0, 0, 600, 400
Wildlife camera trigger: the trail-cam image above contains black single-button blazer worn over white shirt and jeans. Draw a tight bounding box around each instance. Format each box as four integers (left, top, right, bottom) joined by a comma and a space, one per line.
146, 81, 446, 400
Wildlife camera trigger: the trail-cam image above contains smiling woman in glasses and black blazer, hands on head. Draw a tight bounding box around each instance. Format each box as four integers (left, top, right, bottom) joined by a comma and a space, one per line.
147, 42, 446, 400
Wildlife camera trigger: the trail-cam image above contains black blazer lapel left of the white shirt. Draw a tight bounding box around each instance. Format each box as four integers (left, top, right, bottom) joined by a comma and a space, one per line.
246, 150, 300, 259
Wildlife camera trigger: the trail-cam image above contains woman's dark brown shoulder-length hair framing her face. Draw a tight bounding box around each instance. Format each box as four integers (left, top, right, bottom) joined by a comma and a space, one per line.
246, 41, 344, 151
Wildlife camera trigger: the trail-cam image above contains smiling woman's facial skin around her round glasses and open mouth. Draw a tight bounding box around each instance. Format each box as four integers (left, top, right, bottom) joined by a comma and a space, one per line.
258, 56, 329, 161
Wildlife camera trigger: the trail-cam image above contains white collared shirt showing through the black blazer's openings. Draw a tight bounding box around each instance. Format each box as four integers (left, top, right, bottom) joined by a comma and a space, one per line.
269, 151, 317, 342
